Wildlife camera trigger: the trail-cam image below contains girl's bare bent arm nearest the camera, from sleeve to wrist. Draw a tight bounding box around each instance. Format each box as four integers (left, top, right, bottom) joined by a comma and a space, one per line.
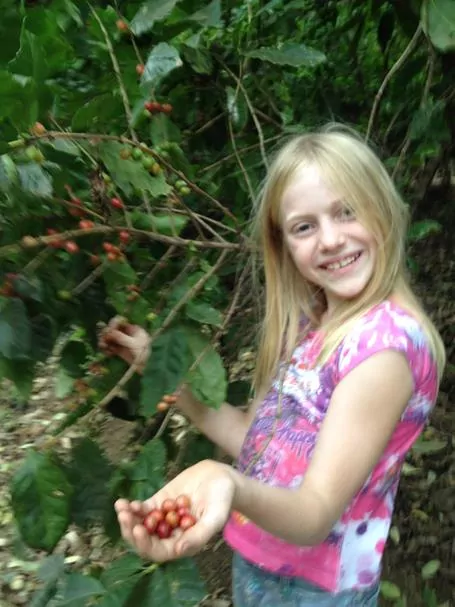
229, 351, 413, 545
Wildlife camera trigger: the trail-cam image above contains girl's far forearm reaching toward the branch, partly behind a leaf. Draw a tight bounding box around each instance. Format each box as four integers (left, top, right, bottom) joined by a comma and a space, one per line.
176, 387, 249, 459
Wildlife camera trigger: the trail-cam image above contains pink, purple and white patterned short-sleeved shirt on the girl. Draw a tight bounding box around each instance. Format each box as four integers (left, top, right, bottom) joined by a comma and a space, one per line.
224, 301, 438, 592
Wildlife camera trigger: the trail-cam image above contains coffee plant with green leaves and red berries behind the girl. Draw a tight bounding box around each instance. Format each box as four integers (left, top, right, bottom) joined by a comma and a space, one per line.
0, 0, 455, 607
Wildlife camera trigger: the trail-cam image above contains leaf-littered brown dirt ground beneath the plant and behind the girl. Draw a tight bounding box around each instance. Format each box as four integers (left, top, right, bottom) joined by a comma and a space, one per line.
0, 189, 455, 607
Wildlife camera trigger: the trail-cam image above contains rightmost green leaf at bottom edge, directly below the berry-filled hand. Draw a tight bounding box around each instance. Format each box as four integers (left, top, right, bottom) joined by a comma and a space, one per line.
145, 559, 206, 607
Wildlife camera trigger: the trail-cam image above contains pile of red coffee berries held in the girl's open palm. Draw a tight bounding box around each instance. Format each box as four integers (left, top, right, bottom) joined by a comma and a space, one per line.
143, 495, 196, 539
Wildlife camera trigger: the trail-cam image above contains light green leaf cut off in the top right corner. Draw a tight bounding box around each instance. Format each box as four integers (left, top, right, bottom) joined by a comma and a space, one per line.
421, 0, 455, 53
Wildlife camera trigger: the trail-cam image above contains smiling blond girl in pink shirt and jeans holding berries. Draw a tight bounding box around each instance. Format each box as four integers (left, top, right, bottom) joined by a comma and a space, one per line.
103, 126, 444, 607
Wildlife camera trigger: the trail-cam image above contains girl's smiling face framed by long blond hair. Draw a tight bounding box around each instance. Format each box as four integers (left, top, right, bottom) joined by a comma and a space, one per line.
281, 165, 377, 315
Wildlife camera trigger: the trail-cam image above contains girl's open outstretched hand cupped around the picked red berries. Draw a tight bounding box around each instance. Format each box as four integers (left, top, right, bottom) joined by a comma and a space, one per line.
115, 460, 235, 562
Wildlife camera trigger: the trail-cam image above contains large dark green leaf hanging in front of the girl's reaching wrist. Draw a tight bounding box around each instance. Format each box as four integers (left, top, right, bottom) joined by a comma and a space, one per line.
140, 327, 191, 416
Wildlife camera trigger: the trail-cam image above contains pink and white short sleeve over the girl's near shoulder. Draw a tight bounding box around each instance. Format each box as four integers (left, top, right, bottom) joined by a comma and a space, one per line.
337, 301, 434, 388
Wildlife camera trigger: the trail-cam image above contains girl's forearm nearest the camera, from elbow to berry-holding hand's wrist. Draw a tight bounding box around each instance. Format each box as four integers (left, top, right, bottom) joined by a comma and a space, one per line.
229, 467, 331, 546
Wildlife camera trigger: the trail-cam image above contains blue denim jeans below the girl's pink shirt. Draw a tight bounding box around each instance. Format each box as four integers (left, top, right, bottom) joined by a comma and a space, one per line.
232, 554, 379, 607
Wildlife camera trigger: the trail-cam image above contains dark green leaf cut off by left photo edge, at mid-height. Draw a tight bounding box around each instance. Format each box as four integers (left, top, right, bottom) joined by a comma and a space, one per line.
0, 297, 32, 360
